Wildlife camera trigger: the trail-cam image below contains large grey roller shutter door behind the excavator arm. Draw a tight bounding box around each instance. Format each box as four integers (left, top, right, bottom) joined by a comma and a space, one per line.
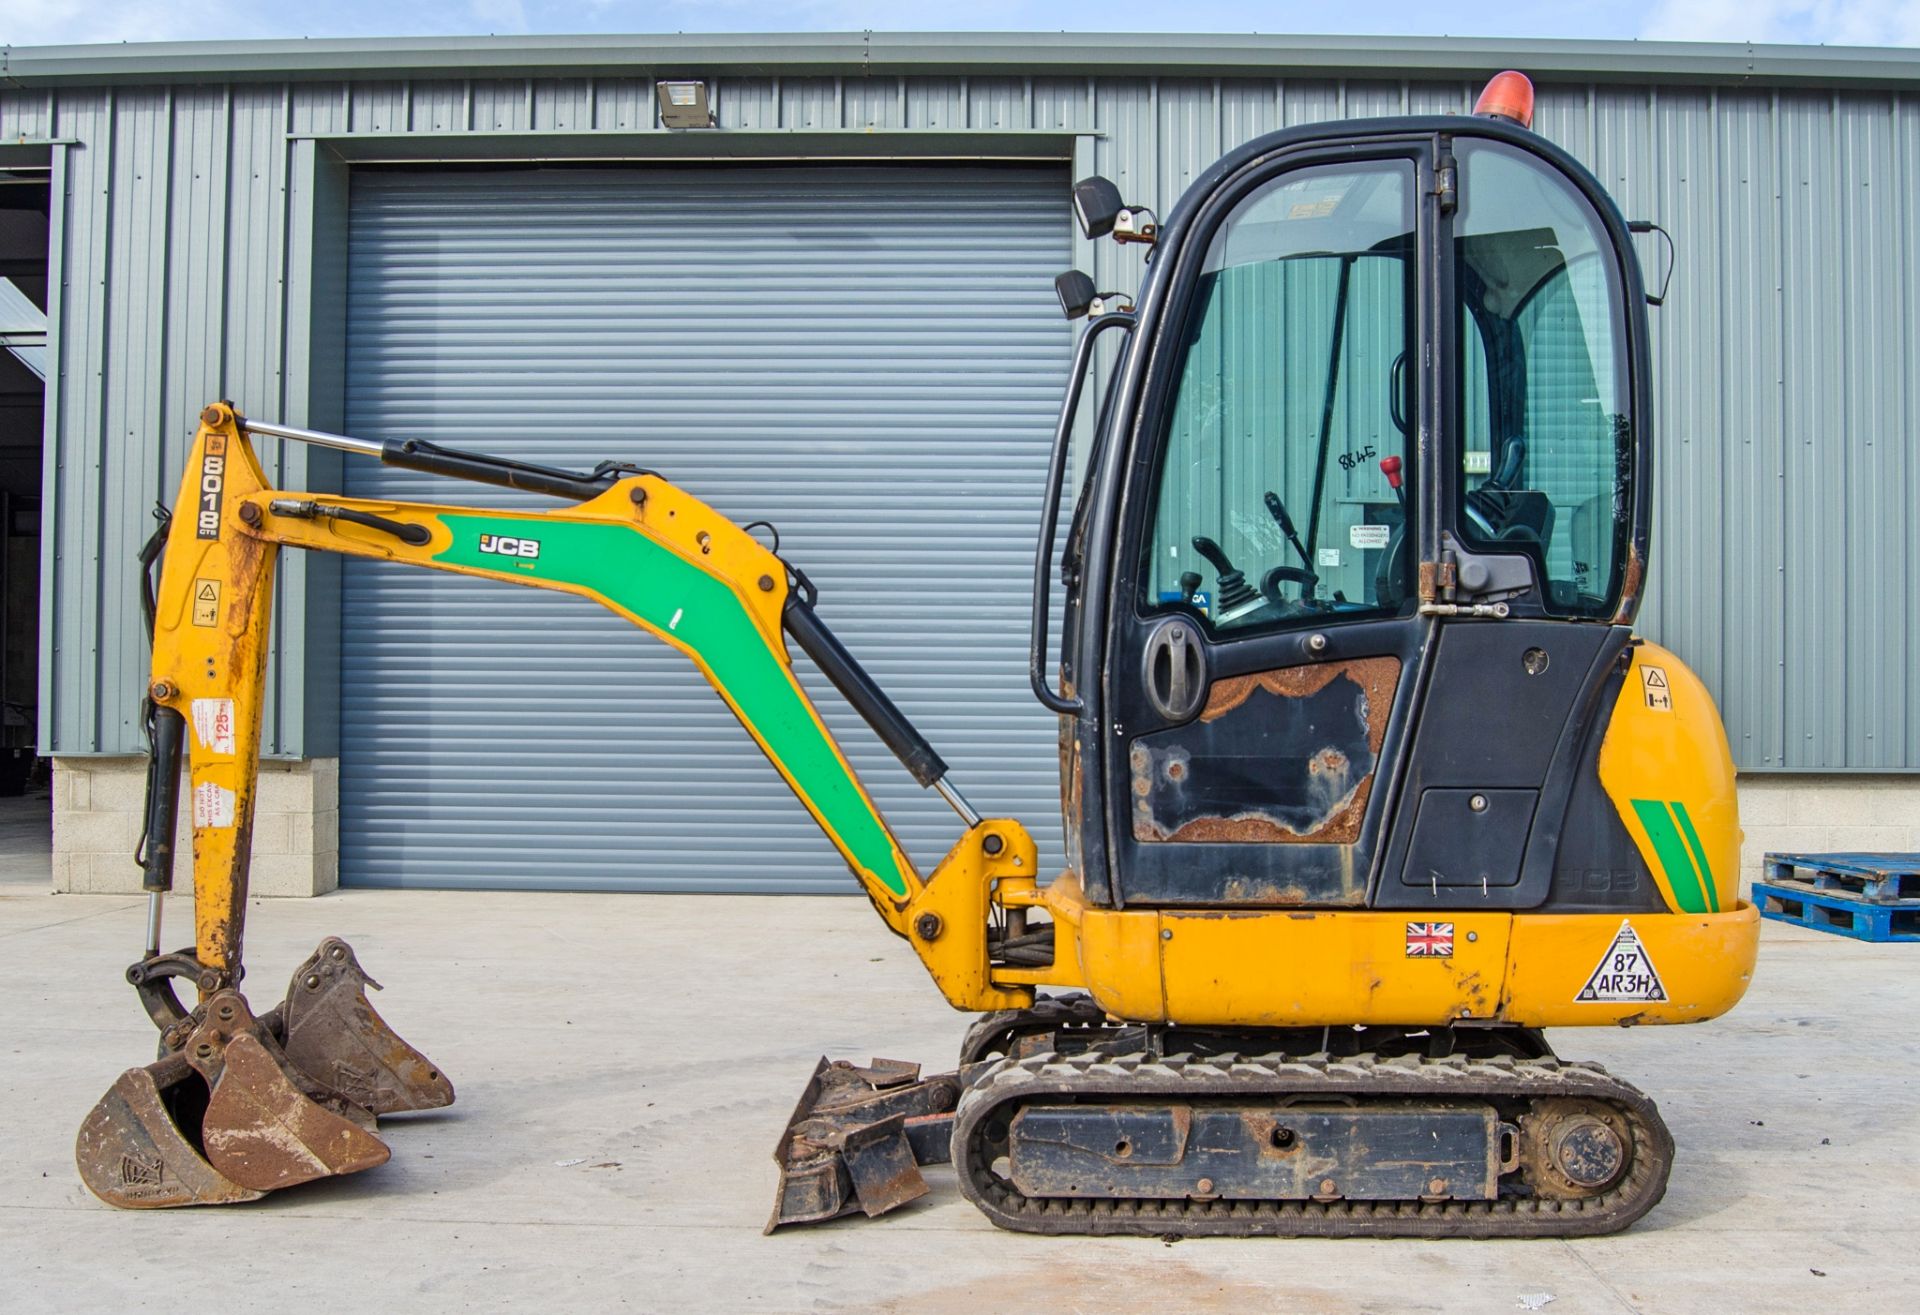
340, 165, 1071, 891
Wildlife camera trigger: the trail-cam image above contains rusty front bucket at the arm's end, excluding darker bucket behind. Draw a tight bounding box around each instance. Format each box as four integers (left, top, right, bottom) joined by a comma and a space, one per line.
75, 991, 390, 1207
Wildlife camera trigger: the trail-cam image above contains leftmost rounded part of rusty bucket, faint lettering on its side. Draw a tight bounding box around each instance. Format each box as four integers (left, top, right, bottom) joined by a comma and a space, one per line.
73, 1056, 263, 1209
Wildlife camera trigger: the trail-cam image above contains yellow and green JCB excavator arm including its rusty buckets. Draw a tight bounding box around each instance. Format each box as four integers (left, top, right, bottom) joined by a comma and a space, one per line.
79, 403, 1035, 1207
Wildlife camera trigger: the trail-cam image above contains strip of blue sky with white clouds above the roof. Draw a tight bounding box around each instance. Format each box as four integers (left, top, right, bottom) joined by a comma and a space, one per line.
0, 0, 1920, 46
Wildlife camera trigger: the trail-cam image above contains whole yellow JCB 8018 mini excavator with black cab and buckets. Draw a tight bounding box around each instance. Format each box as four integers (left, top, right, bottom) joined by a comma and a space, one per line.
79, 73, 1759, 1236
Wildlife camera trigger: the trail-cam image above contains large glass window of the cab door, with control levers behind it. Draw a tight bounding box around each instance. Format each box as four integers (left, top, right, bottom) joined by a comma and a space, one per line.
1140, 159, 1417, 634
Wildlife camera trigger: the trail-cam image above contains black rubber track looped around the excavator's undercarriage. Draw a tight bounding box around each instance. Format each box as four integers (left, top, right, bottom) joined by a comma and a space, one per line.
952, 1054, 1674, 1238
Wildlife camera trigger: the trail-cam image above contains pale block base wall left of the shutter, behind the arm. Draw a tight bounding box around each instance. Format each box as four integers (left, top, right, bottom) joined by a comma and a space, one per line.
54, 758, 340, 895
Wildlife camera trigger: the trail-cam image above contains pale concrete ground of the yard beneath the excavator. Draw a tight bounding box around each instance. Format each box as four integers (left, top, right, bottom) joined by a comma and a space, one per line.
0, 795, 1920, 1315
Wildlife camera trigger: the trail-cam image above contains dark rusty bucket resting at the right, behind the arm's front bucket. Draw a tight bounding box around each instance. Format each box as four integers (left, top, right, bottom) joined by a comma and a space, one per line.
263, 937, 453, 1113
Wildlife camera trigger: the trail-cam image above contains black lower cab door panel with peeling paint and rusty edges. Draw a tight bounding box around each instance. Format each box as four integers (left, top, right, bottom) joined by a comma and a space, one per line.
1129, 657, 1400, 845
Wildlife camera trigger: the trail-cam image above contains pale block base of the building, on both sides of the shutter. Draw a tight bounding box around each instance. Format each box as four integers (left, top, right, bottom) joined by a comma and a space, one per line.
41, 758, 1920, 895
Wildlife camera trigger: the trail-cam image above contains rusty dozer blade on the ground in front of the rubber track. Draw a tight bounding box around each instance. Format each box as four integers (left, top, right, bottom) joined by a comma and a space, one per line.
766, 1058, 960, 1232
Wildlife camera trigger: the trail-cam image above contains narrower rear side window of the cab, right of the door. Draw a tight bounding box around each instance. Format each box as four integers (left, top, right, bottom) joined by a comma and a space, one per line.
1453, 142, 1632, 616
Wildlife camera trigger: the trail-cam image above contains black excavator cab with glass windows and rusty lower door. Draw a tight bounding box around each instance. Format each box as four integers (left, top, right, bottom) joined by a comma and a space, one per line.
1043, 105, 1657, 912
